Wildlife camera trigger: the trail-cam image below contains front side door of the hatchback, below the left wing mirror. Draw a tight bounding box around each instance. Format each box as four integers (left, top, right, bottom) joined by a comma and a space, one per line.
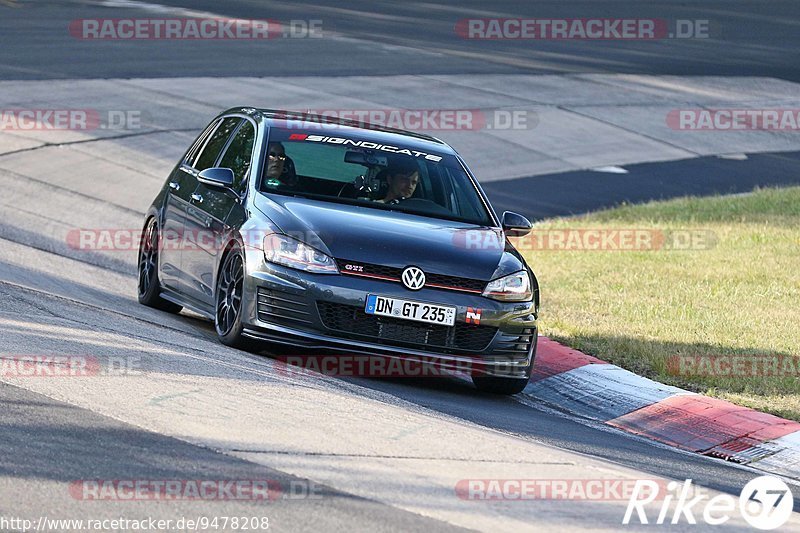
181, 117, 245, 309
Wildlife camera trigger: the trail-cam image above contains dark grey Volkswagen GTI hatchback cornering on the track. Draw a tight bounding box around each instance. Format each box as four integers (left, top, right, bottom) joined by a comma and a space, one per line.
139, 108, 539, 394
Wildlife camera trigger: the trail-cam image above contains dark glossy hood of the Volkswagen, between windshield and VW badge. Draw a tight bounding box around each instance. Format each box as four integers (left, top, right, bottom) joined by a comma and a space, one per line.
255, 194, 524, 280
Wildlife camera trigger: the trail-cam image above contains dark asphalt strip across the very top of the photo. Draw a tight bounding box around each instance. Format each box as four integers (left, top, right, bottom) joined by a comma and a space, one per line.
0, 0, 800, 81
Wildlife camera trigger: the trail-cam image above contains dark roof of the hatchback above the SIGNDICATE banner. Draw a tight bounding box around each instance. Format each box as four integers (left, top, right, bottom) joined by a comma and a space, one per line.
220, 107, 457, 155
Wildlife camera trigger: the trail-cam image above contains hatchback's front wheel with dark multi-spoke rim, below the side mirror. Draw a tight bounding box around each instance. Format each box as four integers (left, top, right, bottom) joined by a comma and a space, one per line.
214, 243, 256, 350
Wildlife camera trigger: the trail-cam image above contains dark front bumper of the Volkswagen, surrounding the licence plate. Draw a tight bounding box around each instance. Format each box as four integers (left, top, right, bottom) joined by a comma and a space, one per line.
238, 253, 538, 378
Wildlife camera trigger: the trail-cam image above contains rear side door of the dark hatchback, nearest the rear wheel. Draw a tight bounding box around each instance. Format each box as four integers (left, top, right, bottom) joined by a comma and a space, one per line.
159, 119, 222, 291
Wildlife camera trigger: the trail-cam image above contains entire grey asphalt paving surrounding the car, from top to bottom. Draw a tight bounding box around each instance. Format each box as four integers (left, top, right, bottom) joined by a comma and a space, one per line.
0, 0, 800, 532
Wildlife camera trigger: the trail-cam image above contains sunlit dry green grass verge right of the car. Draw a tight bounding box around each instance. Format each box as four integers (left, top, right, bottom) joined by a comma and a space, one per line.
523, 187, 800, 420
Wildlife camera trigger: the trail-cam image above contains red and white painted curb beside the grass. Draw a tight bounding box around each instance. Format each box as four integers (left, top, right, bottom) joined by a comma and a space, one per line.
524, 337, 800, 479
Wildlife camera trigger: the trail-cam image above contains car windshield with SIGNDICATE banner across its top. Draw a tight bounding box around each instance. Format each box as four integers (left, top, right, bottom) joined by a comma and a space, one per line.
261, 128, 494, 226
